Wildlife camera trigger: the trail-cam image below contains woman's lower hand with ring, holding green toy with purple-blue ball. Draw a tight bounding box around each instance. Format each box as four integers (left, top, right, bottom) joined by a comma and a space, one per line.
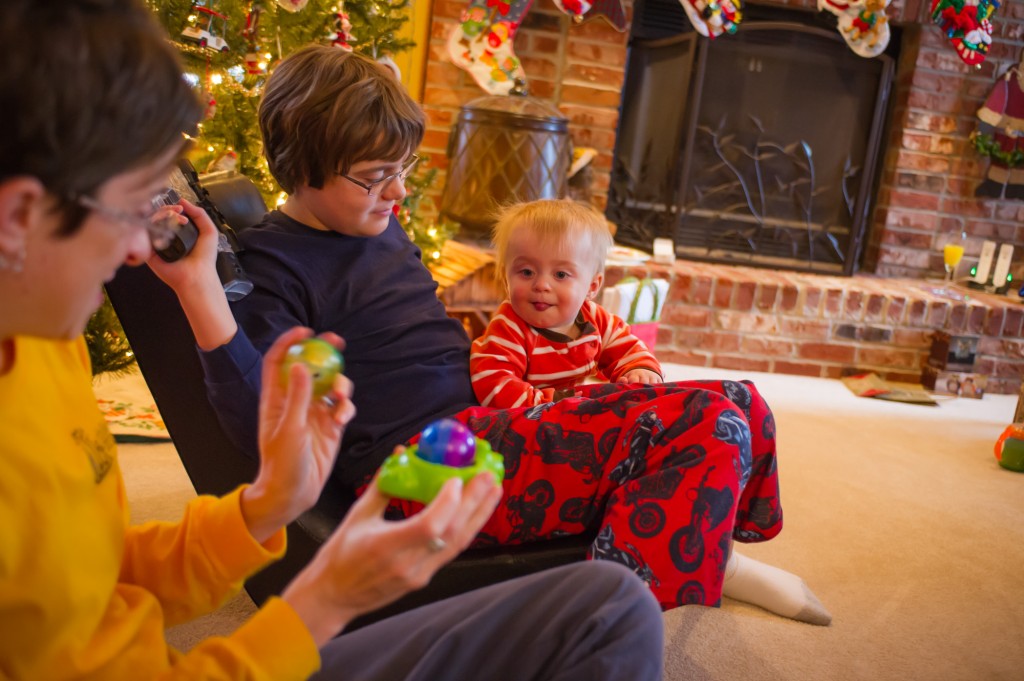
282, 472, 502, 645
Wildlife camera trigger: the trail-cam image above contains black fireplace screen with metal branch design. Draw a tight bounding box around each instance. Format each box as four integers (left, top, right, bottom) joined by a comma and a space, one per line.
607, 0, 894, 274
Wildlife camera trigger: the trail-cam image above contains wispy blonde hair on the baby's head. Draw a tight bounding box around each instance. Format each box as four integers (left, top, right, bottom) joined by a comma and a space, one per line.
490, 199, 614, 281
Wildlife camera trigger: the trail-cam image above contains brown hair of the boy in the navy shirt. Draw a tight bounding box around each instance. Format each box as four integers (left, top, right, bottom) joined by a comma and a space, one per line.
259, 45, 425, 193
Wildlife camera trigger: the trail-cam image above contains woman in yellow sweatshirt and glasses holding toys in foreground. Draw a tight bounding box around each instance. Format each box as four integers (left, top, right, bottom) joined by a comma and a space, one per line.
0, 0, 662, 680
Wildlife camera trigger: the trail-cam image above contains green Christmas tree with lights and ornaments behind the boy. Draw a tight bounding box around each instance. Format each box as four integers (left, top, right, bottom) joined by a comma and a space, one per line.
87, 0, 455, 375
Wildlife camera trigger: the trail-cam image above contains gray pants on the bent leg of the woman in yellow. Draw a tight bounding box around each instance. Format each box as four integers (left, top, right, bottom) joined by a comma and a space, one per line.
313, 560, 664, 681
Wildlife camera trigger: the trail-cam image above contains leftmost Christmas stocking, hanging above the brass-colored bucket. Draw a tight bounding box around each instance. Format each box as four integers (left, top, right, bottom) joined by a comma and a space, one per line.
447, 0, 532, 94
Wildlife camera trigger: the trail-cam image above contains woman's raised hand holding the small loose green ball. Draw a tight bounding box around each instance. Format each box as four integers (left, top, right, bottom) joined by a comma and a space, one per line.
242, 327, 355, 543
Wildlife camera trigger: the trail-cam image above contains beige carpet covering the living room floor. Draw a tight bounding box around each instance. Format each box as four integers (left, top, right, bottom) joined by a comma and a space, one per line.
100, 367, 1024, 681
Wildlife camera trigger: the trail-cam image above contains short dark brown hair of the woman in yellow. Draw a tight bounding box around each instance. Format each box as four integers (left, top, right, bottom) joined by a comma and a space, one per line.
0, 0, 202, 235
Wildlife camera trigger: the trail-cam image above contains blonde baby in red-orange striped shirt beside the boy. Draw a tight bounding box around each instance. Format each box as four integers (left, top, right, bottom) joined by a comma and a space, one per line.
470, 200, 663, 409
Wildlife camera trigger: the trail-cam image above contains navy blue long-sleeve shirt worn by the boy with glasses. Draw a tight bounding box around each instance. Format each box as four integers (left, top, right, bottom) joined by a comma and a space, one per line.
201, 211, 476, 487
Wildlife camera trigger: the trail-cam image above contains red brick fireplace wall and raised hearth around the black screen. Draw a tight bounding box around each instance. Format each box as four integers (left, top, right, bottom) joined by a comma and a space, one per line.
422, 0, 1024, 392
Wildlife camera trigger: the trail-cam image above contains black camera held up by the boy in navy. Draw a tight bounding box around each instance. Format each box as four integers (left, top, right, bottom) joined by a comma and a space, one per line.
154, 159, 253, 300
